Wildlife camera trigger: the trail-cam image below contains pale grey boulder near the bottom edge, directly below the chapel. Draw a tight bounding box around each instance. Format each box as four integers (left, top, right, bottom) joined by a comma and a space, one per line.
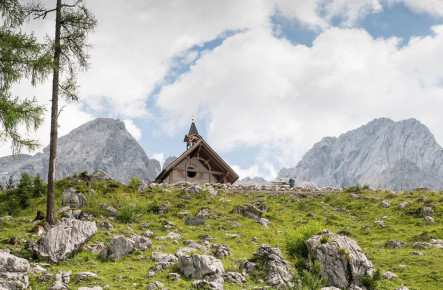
178, 254, 225, 279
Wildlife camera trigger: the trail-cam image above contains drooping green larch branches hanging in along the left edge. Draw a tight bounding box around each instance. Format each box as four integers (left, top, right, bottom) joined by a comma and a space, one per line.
0, 0, 52, 155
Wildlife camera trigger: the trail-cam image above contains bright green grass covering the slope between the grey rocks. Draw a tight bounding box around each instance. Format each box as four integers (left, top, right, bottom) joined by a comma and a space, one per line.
0, 179, 443, 289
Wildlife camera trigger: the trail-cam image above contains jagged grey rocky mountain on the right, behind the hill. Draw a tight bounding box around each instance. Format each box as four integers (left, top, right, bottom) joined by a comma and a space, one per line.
278, 118, 443, 190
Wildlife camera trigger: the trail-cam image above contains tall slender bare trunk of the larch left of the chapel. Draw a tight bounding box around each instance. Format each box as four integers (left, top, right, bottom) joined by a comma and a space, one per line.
46, 0, 62, 225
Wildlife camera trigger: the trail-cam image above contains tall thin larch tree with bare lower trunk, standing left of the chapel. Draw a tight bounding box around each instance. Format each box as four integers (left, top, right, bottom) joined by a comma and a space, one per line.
29, 0, 97, 225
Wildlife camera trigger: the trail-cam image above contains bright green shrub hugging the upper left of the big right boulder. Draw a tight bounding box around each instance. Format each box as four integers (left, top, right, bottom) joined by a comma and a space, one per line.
284, 222, 324, 258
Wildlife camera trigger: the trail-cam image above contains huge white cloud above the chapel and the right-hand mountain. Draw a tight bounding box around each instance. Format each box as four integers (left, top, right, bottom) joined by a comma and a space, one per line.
157, 26, 443, 175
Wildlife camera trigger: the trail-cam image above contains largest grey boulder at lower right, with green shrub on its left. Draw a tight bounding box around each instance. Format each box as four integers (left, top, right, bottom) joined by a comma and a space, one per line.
306, 230, 374, 288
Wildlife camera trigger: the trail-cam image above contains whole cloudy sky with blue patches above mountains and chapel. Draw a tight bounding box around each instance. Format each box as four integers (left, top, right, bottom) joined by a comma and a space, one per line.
0, 0, 443, 180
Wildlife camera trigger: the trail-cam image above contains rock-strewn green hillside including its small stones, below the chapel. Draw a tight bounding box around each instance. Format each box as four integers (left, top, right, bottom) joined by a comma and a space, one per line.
0, 173, 443, 289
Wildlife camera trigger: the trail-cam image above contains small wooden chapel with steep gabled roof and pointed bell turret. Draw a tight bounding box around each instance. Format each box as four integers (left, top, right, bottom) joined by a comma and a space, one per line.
155, 118, 238, 184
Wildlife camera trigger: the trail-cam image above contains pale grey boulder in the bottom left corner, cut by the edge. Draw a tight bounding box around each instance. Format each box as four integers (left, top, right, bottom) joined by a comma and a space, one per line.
0, 251, 30, 289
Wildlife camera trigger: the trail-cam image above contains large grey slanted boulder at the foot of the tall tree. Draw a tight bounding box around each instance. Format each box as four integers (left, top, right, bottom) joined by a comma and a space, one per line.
27, 218, 97, 263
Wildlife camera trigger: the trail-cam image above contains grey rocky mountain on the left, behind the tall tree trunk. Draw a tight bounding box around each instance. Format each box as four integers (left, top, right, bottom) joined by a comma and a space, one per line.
0, 118, 160, 183
